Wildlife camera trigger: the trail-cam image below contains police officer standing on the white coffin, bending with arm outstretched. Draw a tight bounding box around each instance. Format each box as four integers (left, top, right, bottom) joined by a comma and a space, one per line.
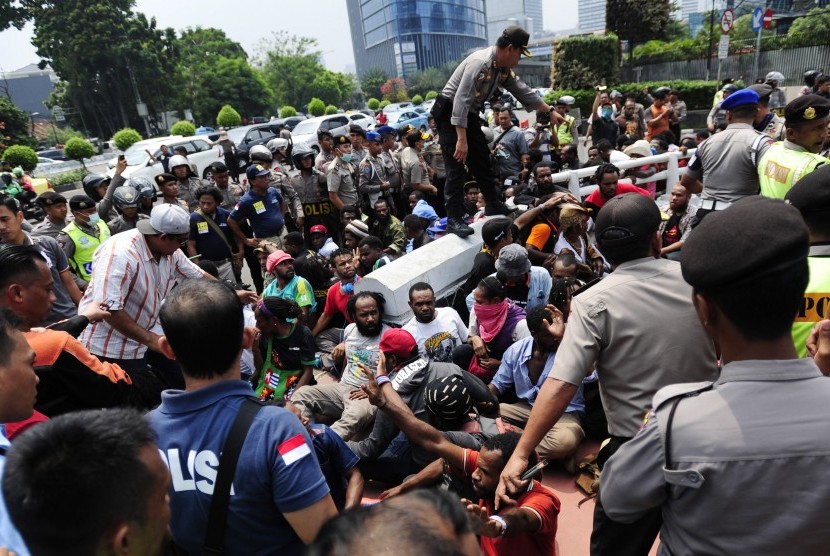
432, 26, 563, 237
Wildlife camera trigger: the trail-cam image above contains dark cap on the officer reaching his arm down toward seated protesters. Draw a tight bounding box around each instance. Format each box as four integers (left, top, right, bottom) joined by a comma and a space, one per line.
596, 193, 664, 249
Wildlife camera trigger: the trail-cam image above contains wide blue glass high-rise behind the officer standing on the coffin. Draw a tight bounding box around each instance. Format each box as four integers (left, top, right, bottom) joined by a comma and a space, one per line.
347, 0, 487, 77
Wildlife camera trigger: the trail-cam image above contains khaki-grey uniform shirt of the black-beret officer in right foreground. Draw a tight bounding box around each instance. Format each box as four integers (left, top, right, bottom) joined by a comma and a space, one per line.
600, 359, 830, 556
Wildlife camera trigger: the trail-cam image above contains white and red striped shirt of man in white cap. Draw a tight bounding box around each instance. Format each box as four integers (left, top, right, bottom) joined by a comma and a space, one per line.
78, 229, 205, 359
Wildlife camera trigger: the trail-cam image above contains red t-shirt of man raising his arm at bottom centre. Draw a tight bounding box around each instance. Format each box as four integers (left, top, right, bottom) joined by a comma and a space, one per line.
464, 450, 560, 556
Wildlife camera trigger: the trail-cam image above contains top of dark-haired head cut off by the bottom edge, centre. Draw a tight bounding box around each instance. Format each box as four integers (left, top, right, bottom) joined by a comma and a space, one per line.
306, 489, 481, 556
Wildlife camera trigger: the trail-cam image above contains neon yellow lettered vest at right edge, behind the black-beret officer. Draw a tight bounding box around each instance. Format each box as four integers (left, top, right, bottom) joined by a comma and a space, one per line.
793, 245, 830, 357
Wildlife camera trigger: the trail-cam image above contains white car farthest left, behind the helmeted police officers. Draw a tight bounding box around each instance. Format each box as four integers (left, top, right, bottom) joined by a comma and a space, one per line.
107, 135, 223, 179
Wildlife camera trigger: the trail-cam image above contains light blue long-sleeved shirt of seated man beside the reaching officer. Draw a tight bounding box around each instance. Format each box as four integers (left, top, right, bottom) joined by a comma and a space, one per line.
490, 336, 585, 415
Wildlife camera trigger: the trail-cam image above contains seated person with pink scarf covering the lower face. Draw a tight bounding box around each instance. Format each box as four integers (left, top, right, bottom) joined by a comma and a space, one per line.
452, 276, 528, 382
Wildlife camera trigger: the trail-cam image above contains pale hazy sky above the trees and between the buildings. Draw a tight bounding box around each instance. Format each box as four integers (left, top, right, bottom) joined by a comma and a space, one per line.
0, 0, 577, 72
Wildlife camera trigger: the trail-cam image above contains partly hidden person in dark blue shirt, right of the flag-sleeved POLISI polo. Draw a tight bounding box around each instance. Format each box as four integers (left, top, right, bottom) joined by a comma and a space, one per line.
282, 400, 365, 512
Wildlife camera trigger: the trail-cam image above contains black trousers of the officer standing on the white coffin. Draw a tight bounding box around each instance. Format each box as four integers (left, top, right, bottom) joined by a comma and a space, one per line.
436, 106, 499, 220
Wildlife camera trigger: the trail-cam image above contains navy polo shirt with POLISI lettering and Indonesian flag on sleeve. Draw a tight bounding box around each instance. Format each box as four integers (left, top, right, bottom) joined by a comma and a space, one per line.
147, 380, 329, 555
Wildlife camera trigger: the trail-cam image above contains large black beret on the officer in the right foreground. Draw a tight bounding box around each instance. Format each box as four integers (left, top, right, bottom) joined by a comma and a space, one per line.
684, 195, 810, 291
